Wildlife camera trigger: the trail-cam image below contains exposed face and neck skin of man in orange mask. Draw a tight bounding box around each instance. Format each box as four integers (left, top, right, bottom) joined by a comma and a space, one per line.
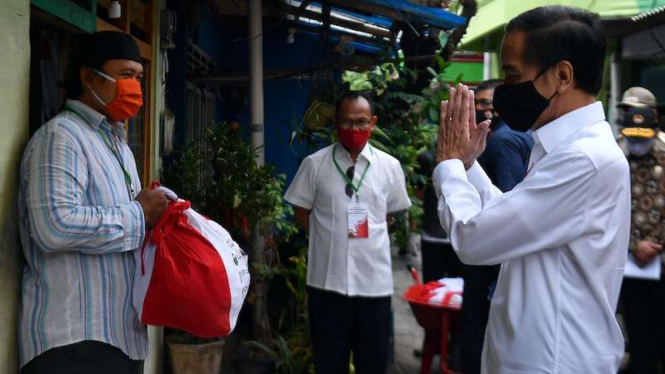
78, 60, 143, 122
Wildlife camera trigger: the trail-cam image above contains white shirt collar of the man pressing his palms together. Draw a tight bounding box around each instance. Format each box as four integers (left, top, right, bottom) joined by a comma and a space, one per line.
533, 101, 605, 153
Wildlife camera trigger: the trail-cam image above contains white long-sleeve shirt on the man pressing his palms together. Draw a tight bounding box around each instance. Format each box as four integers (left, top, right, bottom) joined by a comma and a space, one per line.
433, 102, 630, 374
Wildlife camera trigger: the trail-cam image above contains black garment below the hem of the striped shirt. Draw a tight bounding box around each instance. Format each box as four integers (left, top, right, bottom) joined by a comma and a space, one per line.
21, 340, 143, 374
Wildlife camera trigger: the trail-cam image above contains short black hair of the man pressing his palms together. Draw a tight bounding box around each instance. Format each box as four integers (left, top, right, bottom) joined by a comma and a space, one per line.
506, 5, 607, 95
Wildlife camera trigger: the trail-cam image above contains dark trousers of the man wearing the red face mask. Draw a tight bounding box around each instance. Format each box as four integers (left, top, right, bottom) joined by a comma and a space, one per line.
307, 287, 391, 374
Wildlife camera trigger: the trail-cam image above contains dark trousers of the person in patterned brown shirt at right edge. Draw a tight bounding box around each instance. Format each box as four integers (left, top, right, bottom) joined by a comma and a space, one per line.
621, 278, 665, 374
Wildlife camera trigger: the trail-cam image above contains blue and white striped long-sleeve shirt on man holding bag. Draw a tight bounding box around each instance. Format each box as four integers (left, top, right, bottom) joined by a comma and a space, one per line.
18, 100, 148, 366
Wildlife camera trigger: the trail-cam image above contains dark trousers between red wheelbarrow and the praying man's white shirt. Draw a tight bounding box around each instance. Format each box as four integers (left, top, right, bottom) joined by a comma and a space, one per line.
461, 265, 500, 374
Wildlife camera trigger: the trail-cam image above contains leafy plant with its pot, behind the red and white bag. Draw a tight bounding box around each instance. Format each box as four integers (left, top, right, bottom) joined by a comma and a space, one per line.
162, 124, 296, 374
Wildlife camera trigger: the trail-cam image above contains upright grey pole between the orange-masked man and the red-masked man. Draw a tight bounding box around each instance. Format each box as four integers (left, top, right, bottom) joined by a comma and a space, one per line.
249, 0, 265, 166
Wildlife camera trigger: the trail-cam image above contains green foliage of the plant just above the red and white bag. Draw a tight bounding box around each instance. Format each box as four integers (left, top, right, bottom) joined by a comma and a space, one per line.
162, 125, 297, 240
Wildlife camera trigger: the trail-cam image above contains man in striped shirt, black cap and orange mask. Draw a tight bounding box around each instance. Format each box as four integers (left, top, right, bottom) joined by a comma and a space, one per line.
18, 32, 168, 374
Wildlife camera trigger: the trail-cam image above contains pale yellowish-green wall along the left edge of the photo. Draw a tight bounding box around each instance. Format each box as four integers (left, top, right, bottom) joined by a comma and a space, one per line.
0, 0, 30, 374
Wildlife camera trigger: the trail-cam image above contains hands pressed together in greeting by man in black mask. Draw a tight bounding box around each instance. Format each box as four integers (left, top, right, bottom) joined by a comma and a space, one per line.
436, 84, 490, 170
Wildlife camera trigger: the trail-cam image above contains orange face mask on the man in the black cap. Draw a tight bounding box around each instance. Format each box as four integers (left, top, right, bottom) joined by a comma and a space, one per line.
90, 70, 143, 121
